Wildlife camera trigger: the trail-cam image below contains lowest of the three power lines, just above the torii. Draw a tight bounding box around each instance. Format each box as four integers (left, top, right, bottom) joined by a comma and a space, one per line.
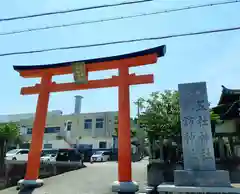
0, 26, 240, 57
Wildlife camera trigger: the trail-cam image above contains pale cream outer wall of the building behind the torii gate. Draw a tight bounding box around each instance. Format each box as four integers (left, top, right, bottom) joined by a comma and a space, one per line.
20, 112, 117, 148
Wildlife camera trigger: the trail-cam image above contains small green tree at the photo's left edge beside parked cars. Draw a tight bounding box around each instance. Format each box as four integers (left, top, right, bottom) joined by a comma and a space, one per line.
0, 123, 20, 175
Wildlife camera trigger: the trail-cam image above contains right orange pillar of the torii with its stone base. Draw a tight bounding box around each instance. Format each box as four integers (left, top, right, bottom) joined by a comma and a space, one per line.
112, 45, 165, 194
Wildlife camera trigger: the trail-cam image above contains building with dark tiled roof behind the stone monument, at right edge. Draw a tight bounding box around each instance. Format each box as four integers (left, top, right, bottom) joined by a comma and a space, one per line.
212, 86, 240, 157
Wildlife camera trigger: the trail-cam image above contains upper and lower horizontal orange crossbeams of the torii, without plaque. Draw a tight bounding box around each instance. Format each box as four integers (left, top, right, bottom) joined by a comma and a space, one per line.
14, 45, 166, 95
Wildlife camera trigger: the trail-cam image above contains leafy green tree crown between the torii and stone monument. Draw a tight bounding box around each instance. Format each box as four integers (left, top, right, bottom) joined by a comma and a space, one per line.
139, 90, 181, 138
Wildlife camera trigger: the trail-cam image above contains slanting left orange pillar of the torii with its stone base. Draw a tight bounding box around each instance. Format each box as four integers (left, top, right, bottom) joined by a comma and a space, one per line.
18, 74, 52, 187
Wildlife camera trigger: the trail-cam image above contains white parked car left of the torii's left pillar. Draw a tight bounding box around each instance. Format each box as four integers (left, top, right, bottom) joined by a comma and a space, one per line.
5, 149, 29, 161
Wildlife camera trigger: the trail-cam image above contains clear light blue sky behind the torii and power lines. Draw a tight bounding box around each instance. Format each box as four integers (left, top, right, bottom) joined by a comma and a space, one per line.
0, 0, 240, 116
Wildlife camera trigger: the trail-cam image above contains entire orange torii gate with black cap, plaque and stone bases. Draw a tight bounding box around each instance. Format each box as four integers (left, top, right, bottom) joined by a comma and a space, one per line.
14, 45, 166, 193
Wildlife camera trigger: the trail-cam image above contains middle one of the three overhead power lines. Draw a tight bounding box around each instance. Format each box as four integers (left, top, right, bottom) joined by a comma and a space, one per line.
0, 0, 240, 36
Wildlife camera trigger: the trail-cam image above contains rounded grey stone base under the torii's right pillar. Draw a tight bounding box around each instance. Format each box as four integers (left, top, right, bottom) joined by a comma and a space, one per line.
112, 181, 139, 194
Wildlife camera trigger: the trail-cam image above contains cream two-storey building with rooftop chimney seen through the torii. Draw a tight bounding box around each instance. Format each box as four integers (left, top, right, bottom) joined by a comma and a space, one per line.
19, 96, 117, 149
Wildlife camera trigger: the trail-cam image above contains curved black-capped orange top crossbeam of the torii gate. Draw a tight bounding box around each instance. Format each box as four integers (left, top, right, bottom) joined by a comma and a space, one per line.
13, 45, 166, 78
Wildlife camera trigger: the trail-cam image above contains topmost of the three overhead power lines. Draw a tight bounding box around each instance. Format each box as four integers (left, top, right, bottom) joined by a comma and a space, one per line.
0, 0, 153, 22
